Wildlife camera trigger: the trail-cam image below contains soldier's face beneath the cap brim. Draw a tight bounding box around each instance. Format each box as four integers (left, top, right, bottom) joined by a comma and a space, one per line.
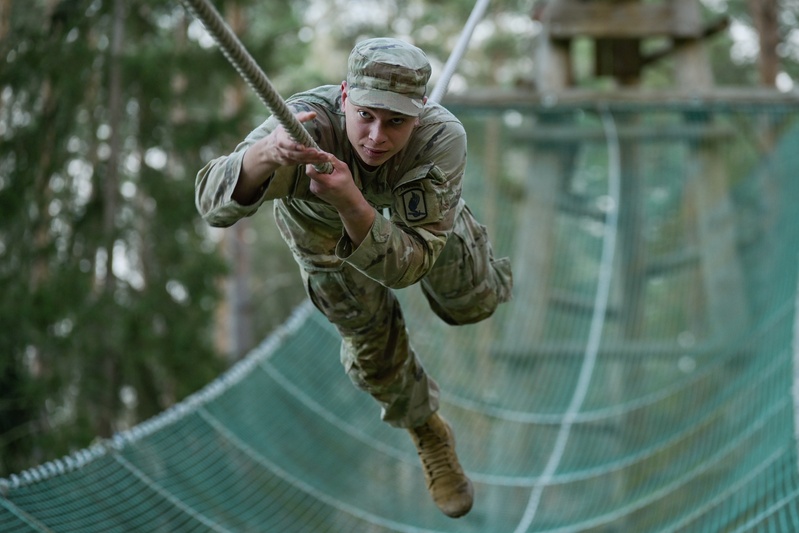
342, 91, 417, 167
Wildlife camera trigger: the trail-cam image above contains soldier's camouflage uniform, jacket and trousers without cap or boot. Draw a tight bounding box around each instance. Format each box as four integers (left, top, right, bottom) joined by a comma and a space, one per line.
196, 86, 511, 427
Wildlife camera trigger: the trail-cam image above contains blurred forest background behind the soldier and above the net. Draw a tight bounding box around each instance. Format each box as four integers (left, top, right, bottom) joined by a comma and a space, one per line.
0, 0, 799, 476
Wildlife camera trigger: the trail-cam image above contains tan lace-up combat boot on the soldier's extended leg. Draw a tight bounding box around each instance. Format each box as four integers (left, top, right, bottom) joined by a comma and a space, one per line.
408, 413, 474, 518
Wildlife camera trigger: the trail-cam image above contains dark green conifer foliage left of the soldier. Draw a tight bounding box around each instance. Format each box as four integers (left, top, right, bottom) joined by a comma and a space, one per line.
0, 0, 302, 475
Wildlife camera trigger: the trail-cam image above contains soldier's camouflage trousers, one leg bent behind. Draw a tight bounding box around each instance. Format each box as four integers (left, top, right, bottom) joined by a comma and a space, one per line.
274, 200, 512, 427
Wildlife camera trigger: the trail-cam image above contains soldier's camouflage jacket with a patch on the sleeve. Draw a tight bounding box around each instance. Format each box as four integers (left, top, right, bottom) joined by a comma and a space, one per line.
195, 85, 466, 288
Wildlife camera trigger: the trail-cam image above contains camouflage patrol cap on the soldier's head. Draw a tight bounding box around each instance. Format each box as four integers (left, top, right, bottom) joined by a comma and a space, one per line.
347, 37, 431, 117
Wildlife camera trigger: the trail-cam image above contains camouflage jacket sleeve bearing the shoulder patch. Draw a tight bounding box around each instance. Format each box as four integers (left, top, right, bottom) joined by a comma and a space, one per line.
336, 120, 466, 289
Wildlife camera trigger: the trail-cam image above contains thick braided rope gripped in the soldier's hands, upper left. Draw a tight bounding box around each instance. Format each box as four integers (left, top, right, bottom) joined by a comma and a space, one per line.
183, 0, 333, 174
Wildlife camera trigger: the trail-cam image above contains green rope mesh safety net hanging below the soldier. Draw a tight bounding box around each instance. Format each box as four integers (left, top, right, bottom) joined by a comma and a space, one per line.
0, 103, 799, 533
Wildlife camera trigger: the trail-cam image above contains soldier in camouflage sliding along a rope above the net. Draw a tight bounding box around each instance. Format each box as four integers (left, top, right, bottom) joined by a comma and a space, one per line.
196, 38, 512, 518
